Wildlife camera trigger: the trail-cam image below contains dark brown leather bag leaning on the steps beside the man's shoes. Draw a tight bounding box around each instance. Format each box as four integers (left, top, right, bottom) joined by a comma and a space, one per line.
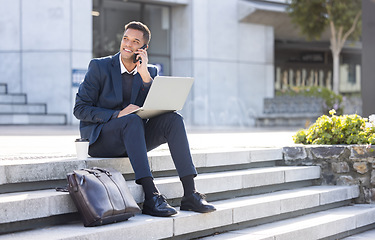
67, 168, 140, 227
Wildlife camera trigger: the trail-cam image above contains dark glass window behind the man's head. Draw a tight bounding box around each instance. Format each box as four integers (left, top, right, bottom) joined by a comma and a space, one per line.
93, 0, 171, 75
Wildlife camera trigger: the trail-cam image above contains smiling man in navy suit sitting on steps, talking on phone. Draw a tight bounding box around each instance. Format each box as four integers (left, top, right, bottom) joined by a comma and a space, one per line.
74, 22, 216, 216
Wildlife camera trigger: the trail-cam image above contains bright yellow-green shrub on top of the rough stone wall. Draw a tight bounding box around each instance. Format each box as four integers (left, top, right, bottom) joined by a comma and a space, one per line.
293, 109, 375, 145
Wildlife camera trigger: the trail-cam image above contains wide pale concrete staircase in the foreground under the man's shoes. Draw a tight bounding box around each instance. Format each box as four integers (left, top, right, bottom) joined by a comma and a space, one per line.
0, 148, 375, 240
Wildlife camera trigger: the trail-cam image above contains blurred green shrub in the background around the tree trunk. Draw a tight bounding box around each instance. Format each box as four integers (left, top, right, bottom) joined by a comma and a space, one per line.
276, 86, 343, 115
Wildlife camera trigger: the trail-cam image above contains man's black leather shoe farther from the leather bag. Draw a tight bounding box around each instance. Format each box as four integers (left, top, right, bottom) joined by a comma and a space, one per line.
180, 192, 216, 213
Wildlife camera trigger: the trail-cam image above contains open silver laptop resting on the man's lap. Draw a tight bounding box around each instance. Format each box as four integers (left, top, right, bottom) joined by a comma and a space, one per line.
131, 76, 194, 119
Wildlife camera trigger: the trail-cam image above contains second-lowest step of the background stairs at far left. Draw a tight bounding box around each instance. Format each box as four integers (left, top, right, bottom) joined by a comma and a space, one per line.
0, 103, 47, 114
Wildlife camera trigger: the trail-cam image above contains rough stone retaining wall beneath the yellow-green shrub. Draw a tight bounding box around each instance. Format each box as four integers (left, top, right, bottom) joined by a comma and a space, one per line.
283, 145, 375, 203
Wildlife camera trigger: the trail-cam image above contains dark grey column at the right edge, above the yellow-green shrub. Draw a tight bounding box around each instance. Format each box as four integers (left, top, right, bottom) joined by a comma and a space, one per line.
361, 0, 375, 117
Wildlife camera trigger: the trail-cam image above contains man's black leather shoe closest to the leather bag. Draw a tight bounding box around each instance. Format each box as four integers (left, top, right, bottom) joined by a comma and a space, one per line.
142, 194, 177, 217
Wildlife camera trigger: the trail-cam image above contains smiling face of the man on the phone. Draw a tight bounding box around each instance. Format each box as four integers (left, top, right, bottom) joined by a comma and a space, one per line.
120, 28, 145, 60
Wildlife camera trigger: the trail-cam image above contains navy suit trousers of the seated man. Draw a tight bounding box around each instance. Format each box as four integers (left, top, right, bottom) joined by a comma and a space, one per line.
89, 112, 197, 183
